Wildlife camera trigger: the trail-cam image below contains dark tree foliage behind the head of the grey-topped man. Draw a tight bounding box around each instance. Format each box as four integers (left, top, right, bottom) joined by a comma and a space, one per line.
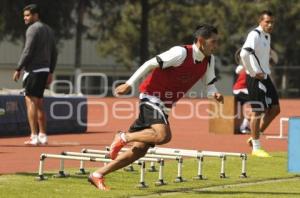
0, 0, 75, 41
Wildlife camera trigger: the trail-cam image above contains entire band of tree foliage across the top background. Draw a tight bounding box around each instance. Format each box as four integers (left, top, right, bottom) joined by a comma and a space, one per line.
0, 0, 300, 67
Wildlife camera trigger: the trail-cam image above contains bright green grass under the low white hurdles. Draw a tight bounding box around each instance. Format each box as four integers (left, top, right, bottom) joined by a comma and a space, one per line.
0, 153, 300, 198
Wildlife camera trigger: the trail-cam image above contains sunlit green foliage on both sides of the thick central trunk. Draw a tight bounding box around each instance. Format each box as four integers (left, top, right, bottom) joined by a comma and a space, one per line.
94, 0, 300, 69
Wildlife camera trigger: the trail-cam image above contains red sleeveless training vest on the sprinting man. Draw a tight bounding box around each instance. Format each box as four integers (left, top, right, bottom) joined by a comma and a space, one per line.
139, 45, 209, 108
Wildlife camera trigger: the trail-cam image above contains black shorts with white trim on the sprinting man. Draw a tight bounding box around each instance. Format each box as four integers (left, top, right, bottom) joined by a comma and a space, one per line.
129, 99, 169, 132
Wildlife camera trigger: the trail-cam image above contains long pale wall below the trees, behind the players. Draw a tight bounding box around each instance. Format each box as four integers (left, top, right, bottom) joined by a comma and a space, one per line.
0, 40, 232, 97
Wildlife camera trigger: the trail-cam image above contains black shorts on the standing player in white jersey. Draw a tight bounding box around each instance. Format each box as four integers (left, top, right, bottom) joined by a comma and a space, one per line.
246, 75, 279, 112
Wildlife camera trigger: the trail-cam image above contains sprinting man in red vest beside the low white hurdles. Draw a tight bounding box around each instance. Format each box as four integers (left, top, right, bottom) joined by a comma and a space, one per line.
88, 24, 223, 190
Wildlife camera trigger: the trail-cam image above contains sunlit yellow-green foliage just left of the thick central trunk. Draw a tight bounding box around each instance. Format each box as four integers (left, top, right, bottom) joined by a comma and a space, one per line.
97, 2, 140, 68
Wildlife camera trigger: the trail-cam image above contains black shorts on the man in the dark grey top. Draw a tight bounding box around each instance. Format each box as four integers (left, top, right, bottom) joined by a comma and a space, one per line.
23, 72, 49, 98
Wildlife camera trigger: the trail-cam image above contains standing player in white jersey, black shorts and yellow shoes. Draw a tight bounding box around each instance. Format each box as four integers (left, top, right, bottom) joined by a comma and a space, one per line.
240, 11, 280, 157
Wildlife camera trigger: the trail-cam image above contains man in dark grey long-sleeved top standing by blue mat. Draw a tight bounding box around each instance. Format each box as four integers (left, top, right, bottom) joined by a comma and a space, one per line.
13, 4, 57, 145
